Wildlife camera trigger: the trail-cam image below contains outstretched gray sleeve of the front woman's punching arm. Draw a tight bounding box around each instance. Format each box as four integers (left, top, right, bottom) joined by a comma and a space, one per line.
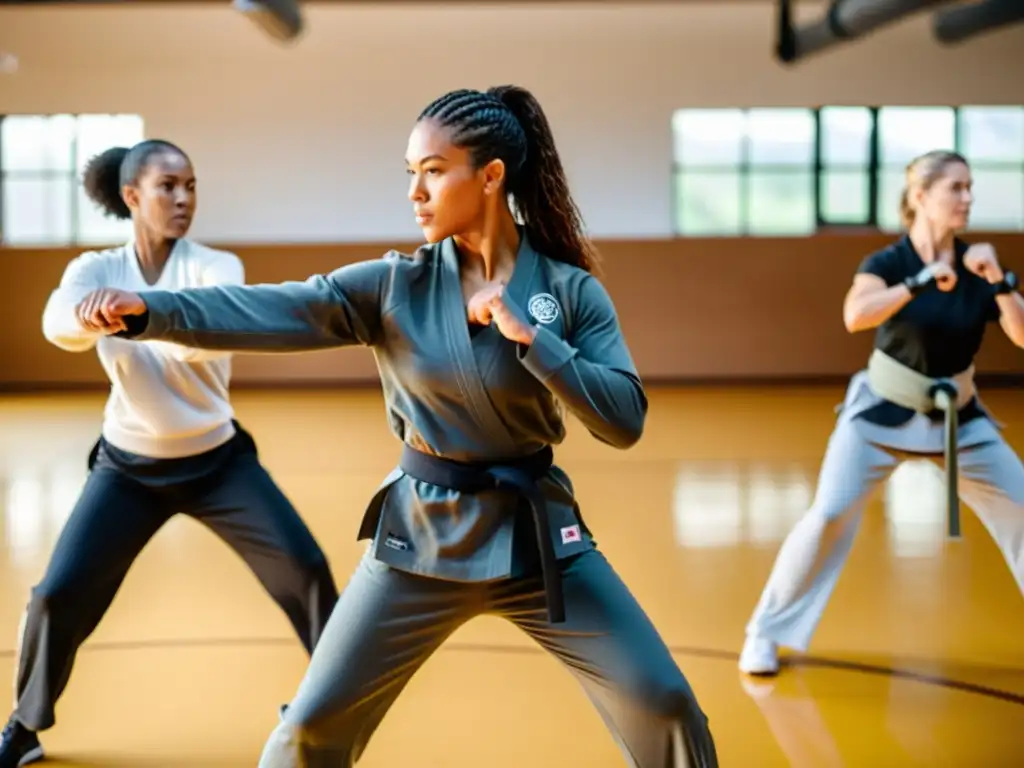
118, 258, 391, 352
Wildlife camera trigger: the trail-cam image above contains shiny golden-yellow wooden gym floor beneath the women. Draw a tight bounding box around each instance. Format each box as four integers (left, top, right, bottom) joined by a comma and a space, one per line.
0, 389, 1024, 768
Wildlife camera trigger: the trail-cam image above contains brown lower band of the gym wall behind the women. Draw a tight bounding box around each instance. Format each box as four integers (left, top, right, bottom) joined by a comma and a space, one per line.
0, 234, 1024, 390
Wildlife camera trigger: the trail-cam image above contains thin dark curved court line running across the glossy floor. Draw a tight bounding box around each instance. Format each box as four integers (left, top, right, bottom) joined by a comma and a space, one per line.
0, 638, 1024, 707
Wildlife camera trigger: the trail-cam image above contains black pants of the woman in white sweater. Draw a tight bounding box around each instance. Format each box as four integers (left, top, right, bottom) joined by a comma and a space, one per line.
15, 425, 338, 731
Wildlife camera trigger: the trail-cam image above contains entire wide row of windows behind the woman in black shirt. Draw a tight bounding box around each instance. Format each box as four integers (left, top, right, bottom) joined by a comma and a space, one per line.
672, 105, 1024, 237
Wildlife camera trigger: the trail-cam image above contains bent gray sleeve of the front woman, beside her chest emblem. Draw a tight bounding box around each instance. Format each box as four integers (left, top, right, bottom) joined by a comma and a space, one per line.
519, 276, 647, 449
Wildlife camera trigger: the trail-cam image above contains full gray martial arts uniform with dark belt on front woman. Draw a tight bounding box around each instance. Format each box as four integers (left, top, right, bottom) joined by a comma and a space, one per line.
119, 231, 718, 768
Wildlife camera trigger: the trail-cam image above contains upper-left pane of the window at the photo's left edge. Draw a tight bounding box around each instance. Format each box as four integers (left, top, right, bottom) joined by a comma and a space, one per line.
0, 115, 75, 171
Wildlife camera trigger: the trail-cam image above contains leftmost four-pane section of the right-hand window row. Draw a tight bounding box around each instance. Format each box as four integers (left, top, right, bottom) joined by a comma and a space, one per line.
673, 109, 815, 237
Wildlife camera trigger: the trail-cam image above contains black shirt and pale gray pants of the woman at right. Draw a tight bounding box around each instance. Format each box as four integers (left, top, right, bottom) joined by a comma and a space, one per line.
746, 237, 1024, 650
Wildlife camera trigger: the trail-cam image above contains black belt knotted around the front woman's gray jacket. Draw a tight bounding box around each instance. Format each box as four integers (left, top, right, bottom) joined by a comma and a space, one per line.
398, 445, 565, 624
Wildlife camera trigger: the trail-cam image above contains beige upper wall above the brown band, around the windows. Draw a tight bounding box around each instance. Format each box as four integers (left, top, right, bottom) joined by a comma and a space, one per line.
0, 0, 1024, 244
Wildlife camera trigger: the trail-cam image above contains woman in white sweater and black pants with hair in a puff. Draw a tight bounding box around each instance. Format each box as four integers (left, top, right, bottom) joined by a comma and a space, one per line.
0, 140, 338, 768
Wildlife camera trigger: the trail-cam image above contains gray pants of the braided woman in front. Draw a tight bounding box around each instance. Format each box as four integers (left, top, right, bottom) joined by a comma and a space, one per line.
259, 550, 718, 768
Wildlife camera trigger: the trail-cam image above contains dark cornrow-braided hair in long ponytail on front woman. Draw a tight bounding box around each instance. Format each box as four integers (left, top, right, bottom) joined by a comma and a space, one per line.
420, 85, 598, 272
